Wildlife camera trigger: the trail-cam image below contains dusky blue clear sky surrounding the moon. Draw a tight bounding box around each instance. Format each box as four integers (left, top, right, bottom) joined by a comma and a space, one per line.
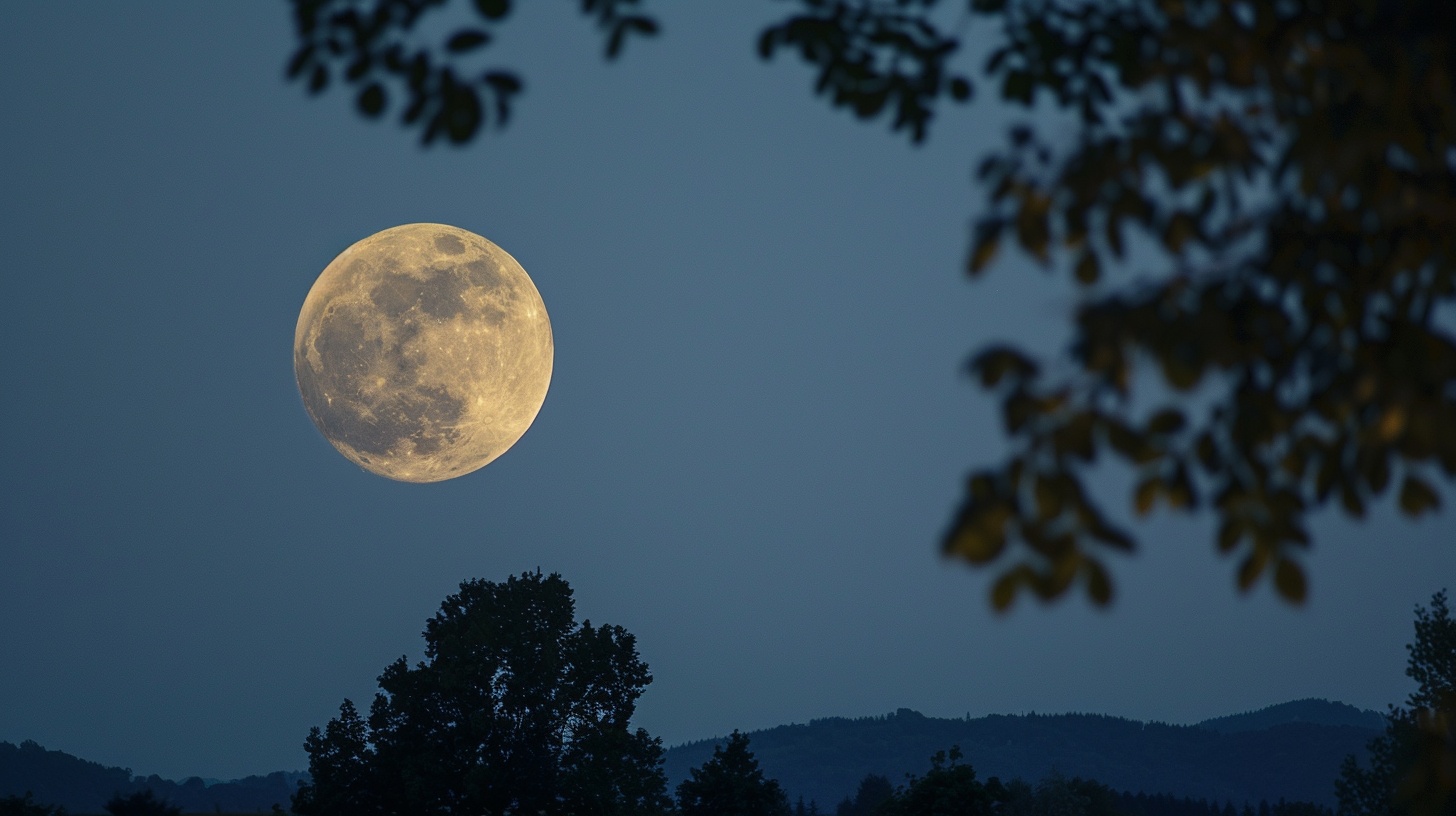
0, 1, 1456, 778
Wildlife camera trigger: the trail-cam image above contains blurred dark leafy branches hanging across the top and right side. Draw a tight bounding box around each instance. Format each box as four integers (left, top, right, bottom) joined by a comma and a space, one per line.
290, 0, 1456, 609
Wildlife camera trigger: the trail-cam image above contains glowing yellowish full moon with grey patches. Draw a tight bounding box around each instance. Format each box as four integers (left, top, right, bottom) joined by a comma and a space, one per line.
293, 224, 553, 482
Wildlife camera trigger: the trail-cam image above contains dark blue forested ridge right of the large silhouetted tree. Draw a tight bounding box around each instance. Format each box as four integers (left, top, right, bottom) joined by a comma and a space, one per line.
667, 704, 1377, 809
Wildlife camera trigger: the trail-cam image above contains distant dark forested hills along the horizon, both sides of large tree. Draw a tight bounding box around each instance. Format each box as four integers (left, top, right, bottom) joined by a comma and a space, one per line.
0, 699, 1383, 816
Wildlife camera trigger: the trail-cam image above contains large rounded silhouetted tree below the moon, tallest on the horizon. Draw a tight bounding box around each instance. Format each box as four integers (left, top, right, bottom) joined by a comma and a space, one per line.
293, 571, 671, 816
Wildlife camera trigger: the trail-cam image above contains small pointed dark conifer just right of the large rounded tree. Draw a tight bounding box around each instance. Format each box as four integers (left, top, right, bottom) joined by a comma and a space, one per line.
677, 731, 789, 816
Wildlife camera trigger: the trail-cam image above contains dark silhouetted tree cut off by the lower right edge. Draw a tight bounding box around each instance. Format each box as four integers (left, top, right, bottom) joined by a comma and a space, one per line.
1333, 590, 1456, 816
